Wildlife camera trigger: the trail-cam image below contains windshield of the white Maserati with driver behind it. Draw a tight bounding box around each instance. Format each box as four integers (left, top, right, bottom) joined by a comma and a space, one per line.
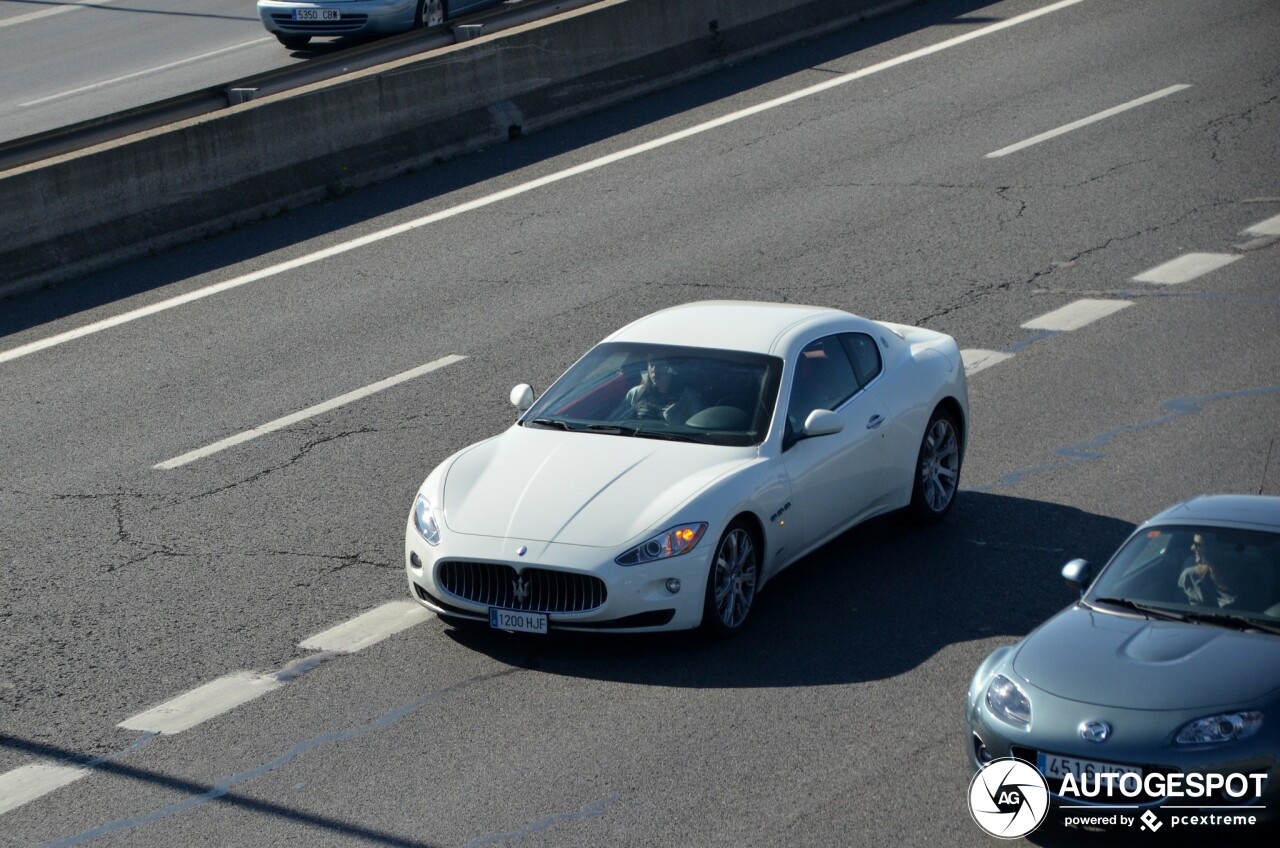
521, 342, 782, 446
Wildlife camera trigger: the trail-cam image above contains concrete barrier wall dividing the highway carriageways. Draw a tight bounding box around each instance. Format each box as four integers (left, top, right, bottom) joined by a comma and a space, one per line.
0, 0, 909, 296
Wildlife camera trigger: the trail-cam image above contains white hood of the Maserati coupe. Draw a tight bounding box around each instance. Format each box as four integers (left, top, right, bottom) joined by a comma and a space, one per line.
443, 427, 755, 547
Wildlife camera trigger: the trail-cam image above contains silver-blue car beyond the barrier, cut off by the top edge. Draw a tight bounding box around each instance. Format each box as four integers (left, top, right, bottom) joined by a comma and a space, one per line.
257, 0, 503, 50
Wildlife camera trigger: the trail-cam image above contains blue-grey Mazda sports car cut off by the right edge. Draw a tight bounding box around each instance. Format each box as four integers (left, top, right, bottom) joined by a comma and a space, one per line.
966, 496, 1280, 825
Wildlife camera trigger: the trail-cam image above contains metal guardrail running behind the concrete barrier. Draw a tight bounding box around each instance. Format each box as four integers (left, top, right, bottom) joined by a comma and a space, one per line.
0, 0, 600, 172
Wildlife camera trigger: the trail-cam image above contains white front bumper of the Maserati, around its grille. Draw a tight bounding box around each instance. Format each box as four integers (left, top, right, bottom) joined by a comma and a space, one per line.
404, 515, 714, 633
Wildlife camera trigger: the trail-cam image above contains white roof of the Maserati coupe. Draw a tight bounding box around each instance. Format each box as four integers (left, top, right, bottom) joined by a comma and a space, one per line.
604, 300, 870, 356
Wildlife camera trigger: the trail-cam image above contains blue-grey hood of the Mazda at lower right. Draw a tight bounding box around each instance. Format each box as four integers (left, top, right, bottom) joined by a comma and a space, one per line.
1014, 606, 1280, 710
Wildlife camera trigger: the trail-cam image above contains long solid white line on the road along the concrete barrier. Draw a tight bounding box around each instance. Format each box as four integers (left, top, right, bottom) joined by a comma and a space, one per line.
0, 0, 1084, 363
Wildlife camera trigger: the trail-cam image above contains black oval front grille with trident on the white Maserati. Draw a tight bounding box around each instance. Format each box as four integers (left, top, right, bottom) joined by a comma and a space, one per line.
435, 560, 607, 612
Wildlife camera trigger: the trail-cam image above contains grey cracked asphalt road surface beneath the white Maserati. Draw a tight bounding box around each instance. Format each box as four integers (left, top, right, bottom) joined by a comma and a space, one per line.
0, 0, 1280, 848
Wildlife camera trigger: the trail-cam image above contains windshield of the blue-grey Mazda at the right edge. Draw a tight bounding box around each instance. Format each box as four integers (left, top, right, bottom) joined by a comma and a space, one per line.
1085, 525, 1280, 632
